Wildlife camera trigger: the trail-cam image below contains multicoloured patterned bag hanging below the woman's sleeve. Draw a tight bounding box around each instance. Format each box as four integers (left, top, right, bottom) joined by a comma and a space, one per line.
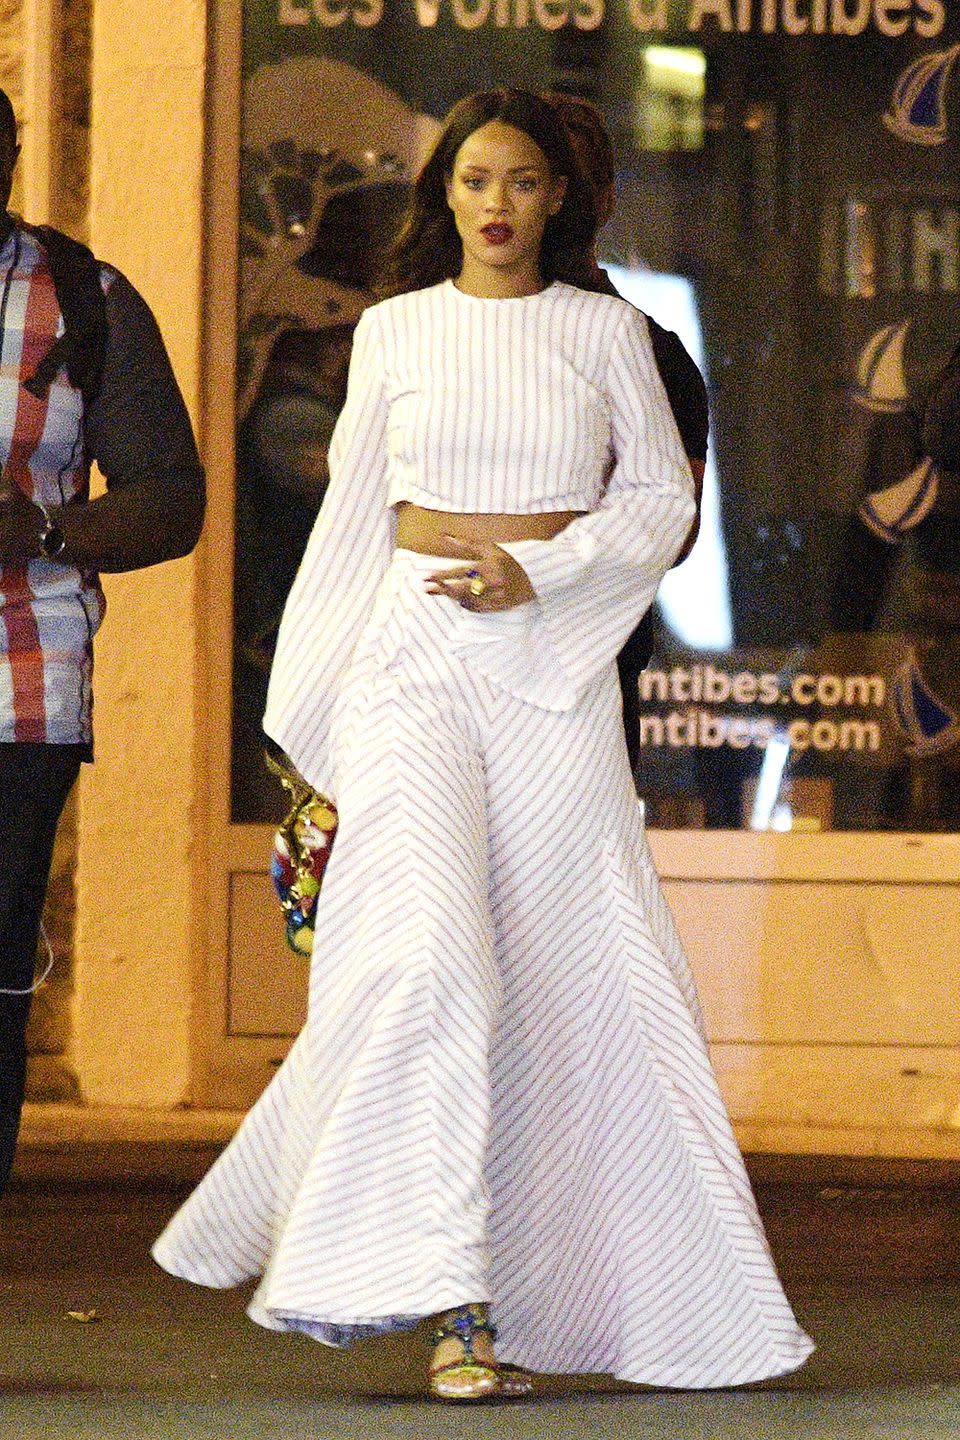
266, 753, 337, 955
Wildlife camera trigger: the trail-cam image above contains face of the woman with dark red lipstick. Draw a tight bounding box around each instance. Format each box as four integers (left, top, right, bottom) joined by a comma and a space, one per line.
446, 120, 567, 285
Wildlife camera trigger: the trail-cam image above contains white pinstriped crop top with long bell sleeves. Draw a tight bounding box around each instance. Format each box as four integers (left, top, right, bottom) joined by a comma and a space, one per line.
265, 281, 694, 792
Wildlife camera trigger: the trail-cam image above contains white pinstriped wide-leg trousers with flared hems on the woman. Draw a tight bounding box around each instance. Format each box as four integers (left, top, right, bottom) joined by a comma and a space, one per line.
154, 552, 812, 1385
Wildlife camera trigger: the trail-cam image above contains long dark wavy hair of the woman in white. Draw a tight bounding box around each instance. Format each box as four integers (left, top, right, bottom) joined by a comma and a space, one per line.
377, 88, 597, 300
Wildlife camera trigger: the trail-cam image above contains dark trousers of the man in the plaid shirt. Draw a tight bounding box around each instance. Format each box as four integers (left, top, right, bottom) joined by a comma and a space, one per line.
0, 742, 83, 1194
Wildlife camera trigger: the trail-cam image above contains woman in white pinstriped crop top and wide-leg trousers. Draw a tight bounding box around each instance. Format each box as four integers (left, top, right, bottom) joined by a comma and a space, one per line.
154, 91, 812, 1400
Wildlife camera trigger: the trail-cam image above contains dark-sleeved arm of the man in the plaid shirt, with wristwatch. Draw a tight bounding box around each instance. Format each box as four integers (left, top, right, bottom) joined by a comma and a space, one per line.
0, 275, 204, 572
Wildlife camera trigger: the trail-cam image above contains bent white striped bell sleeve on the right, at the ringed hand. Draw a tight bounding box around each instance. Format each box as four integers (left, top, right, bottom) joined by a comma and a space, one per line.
476, 308, 695, 710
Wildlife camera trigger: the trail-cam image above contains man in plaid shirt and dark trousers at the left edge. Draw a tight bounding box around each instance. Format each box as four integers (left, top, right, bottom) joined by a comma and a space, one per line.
0, 91, 204, 1192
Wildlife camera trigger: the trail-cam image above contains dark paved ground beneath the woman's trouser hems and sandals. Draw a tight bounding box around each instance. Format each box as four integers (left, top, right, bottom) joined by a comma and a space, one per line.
0, 1179, 960, 1440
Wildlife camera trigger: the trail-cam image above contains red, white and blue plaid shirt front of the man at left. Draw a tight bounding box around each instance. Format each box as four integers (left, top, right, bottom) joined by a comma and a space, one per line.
0, 225, 111, 744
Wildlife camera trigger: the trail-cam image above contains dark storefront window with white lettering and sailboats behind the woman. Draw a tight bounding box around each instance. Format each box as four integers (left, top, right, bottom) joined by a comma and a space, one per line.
232, 0, 960, 832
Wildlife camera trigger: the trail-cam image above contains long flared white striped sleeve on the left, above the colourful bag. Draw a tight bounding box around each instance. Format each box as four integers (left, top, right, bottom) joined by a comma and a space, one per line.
263, 307, 396, 793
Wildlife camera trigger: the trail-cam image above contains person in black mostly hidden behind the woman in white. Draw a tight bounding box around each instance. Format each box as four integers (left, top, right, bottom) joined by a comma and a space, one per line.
545, 91, 710, 769
